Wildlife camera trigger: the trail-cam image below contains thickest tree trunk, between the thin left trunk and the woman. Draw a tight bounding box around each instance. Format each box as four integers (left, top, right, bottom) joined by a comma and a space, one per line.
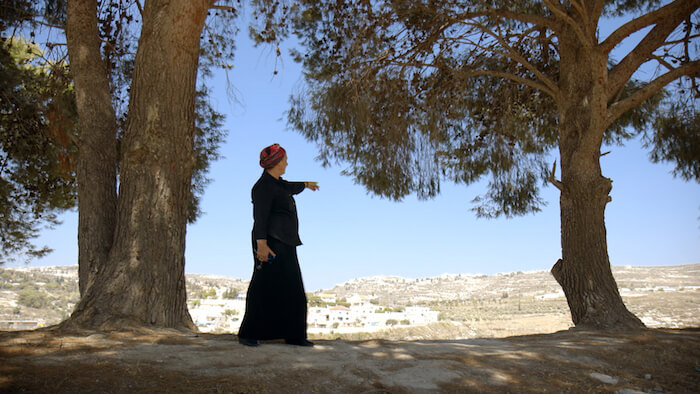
67, 0, 211, 329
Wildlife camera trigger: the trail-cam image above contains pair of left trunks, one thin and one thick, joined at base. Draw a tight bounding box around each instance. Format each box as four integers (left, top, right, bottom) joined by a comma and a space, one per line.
56, 0, 221, 329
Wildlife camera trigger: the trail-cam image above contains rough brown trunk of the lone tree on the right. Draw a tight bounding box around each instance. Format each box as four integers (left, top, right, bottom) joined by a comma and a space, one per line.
552, 26, 644, 329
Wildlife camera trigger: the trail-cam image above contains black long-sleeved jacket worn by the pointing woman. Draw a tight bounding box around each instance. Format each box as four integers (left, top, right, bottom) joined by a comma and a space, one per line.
251, 171, 305, 246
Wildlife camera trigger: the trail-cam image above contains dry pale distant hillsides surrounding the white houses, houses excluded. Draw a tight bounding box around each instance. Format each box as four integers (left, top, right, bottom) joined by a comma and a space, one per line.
0, 264, 700, 337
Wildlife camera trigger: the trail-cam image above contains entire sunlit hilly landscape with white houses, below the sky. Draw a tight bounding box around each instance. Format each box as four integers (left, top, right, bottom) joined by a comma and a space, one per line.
0, 264, 700, 339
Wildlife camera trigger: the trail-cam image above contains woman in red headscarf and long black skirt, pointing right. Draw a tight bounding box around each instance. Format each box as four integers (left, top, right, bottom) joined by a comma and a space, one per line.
238, 144, 318, 346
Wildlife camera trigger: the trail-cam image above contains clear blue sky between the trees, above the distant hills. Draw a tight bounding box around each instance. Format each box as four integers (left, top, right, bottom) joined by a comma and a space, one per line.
7, 16, 700, 291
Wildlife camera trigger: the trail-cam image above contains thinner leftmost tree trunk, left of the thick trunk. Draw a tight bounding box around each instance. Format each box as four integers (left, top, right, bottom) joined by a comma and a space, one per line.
66, 0, 117, 295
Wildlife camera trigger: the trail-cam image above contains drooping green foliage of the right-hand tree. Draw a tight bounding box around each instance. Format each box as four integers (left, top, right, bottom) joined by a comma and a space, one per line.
288, 0, 700, 217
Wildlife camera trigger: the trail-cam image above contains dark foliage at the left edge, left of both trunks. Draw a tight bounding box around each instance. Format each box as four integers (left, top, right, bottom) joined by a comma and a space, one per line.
0, 38, 76, 264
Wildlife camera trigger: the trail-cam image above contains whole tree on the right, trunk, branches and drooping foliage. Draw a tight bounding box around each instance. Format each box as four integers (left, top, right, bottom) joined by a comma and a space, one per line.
289, 0, 700, 328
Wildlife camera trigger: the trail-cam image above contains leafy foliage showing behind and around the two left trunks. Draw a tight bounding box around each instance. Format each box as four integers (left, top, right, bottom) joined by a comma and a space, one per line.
0, 0, 228, 274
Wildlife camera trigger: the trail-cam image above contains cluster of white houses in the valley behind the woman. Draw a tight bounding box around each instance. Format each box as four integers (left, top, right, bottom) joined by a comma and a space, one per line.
190, 293, 438, 333
